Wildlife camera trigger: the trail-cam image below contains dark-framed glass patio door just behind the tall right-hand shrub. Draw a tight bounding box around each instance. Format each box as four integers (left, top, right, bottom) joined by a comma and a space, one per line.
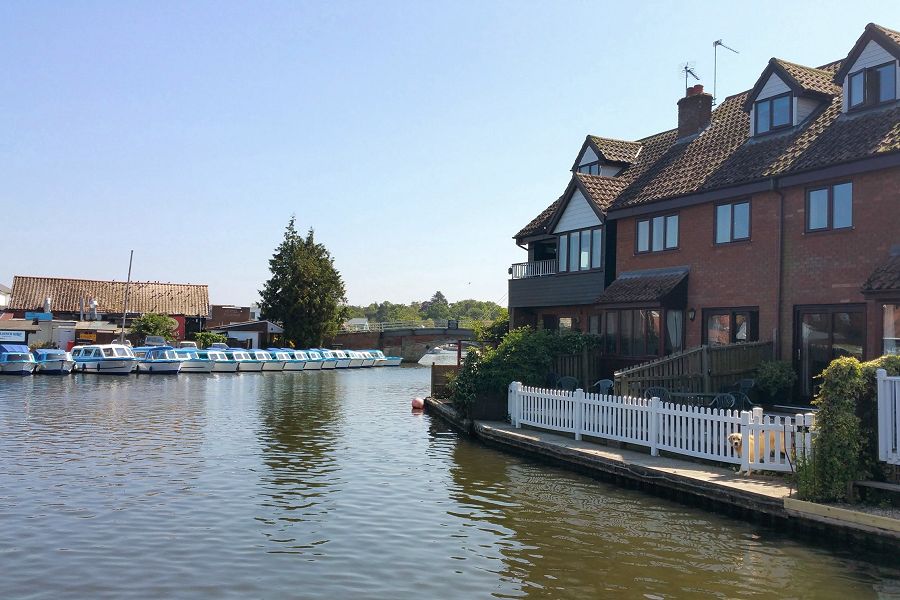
794, 305, 866, 399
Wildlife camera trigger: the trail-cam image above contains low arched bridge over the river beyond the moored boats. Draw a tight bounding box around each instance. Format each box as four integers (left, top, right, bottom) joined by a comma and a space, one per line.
332, 321, 475, 362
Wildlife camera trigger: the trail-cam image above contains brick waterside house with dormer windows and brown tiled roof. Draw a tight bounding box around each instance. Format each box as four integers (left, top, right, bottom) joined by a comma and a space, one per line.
509, 24, 900, 397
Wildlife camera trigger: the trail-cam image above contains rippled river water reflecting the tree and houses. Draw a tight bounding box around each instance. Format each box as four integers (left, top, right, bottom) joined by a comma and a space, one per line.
0, 367, 900, 600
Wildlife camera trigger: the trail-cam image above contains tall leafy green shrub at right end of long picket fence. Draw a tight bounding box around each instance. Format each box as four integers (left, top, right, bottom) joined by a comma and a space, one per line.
797, 357, 864, 502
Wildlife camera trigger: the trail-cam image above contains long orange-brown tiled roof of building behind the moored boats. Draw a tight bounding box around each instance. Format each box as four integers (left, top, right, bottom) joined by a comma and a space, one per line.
9, 275, 209, 316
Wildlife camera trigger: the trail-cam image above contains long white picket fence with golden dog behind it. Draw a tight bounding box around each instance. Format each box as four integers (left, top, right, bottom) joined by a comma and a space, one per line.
509, 381, 816, 471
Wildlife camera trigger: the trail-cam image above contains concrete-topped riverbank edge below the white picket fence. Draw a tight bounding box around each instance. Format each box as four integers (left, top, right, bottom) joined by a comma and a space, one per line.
425, 398, 900, 546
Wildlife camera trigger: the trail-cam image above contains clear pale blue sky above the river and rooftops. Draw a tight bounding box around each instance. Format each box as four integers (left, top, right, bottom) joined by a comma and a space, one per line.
0, 0, 900, 304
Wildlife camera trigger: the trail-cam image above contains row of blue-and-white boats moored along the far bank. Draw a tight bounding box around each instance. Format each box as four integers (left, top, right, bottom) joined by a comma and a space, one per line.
0, 344, 402, 375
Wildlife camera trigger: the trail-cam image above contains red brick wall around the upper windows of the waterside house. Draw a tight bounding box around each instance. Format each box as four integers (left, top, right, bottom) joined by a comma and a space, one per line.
616, 169, 900, 359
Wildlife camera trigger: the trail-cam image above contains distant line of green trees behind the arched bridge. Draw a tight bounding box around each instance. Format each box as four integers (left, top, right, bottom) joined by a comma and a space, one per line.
347, 291, 506, 323
